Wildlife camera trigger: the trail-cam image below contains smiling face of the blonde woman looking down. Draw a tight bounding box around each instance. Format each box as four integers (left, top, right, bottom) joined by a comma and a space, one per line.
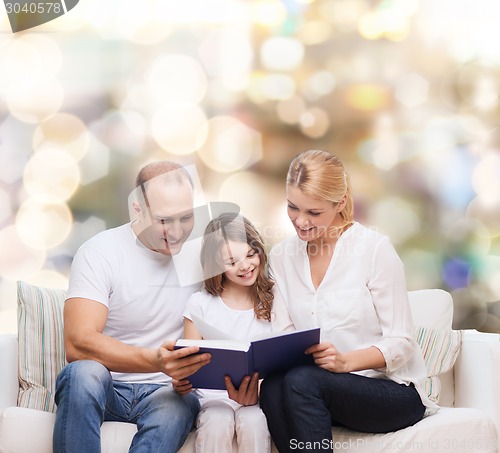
287, 186, 345, 242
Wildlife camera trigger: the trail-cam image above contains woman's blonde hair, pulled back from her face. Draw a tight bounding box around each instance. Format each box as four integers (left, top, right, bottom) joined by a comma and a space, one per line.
286, 150, 354, 225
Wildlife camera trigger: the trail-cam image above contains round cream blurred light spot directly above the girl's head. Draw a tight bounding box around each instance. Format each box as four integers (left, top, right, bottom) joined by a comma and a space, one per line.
198, 116, 262, 172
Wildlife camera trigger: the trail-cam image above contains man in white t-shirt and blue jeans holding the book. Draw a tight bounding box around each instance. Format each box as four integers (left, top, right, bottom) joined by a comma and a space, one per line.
53, 161, 210, 453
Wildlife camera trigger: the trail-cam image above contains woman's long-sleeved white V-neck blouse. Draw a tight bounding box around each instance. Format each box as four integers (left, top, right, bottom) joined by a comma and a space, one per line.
269, 222, 437, 408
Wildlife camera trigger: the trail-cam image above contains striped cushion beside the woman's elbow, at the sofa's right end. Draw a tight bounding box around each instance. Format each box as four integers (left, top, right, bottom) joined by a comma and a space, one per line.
415, 327, 462, 403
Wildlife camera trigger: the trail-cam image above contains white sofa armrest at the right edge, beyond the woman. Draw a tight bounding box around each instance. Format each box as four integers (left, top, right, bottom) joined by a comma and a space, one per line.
454, 330, 500, 433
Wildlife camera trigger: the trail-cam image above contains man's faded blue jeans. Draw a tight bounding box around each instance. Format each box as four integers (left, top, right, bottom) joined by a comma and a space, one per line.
53, 360, 200, 453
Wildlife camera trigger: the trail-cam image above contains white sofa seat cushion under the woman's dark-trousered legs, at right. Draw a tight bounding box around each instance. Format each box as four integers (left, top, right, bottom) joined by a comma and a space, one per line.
334, 407, 497, 453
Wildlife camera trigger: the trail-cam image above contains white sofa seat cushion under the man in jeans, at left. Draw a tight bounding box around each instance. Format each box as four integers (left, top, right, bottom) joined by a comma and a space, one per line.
0, 407, 194, 453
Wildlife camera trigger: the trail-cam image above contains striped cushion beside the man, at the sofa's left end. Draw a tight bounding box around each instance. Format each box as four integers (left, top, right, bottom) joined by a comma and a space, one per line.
17, 282, 66, 412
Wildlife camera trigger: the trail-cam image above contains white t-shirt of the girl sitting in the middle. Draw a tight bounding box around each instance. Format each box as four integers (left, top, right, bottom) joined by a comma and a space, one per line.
184, 290, 271, 409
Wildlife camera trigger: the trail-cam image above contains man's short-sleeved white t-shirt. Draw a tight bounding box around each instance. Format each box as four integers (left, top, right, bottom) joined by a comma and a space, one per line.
67, 223, 199, 383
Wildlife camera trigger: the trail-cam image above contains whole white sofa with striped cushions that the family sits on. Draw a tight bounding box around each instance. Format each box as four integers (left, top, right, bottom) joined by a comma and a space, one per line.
0, 282, 500, 453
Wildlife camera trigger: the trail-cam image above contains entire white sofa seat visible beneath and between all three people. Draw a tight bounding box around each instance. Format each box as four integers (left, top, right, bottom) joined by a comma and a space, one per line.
0, 407, 497, 453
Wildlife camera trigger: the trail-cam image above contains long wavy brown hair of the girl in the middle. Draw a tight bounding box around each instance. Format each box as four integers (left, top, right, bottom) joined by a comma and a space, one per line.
201, 213, 274, 321
